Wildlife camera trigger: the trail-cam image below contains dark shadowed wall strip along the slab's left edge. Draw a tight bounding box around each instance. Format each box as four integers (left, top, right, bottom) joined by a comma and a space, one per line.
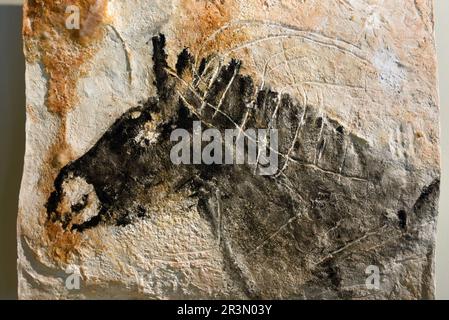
0, 6, 25, 299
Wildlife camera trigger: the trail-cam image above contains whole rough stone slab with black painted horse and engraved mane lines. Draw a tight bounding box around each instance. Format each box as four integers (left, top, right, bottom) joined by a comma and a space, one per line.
18, 0, 440, 299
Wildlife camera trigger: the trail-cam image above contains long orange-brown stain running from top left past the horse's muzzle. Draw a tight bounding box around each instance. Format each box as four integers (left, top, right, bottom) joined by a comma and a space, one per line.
23, 0, 107, 262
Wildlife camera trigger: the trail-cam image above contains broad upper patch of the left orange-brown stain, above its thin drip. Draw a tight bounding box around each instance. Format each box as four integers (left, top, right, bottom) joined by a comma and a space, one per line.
23, 0, 107, 114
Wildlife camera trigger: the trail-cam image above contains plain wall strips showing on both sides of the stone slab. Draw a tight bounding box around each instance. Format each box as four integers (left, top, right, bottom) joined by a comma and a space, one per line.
0, 0, 449, 299
